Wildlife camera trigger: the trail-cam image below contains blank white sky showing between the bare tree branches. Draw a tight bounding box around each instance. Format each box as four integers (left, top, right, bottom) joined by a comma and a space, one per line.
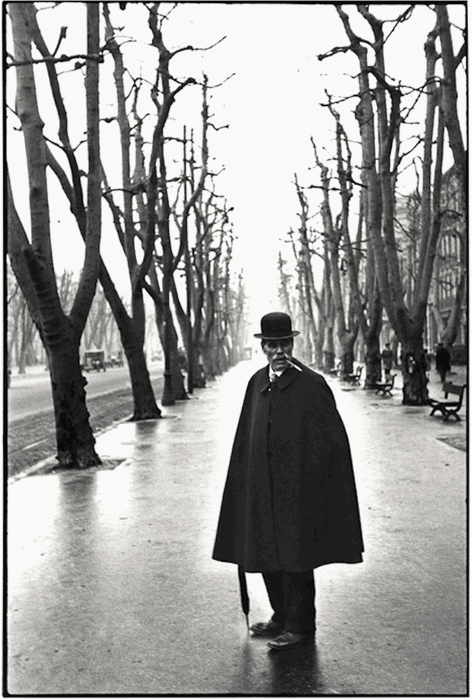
7, 2, 465, 326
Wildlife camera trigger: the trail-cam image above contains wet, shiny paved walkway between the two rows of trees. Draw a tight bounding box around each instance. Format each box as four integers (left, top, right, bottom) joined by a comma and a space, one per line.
6, 360, 467, 696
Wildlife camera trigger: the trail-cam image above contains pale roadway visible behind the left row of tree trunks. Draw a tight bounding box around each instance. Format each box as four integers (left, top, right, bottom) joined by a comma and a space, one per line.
8, 362, 164, 423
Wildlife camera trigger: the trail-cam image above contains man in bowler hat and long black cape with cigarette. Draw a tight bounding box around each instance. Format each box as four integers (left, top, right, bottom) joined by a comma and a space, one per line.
213, 312, 363, 650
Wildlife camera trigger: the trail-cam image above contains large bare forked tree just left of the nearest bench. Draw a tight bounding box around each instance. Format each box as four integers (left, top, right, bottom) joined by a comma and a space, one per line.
319, 4, 462, 404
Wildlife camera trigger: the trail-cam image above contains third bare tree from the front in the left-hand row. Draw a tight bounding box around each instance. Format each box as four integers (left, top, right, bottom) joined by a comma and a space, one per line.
107, 4, 212, 405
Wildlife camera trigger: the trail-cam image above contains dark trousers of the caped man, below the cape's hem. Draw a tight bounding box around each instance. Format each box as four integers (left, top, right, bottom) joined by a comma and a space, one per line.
263, 571, 315, 633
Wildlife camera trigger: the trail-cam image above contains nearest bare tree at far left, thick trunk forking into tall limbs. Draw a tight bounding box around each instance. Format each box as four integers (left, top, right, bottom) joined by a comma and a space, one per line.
7, 3, 101, 468
